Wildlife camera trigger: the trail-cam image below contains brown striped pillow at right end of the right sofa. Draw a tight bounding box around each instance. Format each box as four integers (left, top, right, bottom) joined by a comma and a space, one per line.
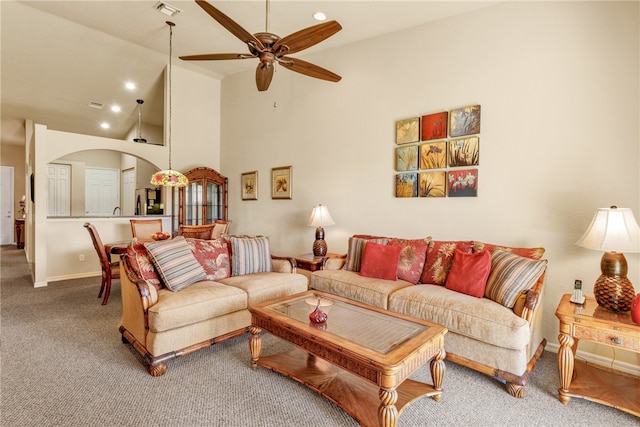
485, 248, 547, 308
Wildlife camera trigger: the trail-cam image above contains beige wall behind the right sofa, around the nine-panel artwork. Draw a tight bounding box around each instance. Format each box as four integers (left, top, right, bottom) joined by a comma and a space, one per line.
221, 2, 640, 367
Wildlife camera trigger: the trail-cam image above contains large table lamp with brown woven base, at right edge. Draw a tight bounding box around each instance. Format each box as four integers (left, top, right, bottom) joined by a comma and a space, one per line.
576, 206, 640, 312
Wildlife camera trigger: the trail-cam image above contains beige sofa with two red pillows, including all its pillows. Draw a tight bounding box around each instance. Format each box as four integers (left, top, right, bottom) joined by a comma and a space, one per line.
309, 235, 547, 397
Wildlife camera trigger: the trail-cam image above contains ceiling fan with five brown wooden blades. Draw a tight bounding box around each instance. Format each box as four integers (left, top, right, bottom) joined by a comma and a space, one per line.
180, 0, 342, 91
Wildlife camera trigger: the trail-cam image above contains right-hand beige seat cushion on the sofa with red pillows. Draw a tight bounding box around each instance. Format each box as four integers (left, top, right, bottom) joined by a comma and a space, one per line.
389, 285, 530, 350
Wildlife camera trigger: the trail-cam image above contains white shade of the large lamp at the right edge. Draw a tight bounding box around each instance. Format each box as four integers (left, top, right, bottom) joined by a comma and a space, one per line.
576, 206, 640, 252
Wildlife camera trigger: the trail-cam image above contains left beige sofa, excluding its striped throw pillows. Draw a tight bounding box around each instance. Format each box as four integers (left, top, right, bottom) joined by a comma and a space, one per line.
119, 239, 308, 376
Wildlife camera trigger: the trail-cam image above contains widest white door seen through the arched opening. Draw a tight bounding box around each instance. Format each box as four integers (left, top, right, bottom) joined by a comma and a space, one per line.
84, 168, 120, 216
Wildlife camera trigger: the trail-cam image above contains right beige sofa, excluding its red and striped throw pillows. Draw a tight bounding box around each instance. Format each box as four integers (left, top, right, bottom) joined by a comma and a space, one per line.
309, 236, 546, 397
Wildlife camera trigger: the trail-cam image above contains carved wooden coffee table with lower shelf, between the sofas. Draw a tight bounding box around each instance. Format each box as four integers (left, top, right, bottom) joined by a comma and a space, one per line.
249, 291, 447, 426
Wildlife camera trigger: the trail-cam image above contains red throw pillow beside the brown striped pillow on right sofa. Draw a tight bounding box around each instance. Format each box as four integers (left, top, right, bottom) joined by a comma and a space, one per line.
445, 249, 491, 298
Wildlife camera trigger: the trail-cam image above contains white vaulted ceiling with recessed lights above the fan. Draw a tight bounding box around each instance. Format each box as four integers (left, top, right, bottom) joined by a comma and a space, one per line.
0, 0, 496, 145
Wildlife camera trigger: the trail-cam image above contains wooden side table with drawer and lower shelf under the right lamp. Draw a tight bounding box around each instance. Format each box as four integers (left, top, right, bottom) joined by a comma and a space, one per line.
556, 294, 640, 416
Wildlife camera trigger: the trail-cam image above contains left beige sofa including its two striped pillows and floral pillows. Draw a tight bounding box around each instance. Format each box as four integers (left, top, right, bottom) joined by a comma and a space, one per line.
119, 236, 308, 376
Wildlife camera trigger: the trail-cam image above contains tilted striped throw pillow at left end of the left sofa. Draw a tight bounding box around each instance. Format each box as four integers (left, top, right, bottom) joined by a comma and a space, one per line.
144, 236, 207, 292
